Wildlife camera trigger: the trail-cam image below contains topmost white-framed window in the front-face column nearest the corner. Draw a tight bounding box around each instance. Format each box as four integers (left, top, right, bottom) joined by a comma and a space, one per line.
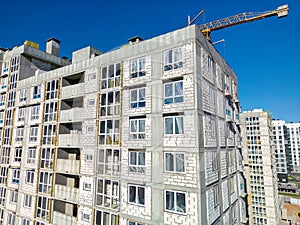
164, 47, 183, 72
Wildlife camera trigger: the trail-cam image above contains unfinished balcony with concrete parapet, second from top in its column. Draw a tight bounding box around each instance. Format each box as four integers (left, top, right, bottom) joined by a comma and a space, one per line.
60, 97, 83, 122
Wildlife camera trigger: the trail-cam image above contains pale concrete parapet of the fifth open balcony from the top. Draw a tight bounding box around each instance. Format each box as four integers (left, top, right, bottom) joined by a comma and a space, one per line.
54, 184, 79, 204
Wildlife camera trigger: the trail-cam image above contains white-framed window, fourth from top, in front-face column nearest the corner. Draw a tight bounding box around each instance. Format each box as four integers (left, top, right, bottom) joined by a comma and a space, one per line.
164, 152, 185, 173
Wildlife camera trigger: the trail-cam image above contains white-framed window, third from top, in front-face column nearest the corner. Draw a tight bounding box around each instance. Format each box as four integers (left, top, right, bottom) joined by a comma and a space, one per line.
164, 115, 184, 135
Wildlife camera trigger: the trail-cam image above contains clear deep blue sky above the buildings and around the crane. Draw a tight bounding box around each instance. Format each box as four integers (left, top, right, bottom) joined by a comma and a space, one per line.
0, 0, 300, 122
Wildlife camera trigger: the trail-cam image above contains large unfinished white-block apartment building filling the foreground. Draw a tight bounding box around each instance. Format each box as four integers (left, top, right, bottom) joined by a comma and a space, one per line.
0, 25, 247, 225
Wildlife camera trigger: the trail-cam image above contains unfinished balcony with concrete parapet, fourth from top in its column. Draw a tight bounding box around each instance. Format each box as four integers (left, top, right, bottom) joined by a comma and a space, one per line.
56, 148, 80, 174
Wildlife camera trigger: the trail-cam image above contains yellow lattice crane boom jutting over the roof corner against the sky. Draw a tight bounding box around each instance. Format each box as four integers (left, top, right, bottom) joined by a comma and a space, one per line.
199, 5, 289, 40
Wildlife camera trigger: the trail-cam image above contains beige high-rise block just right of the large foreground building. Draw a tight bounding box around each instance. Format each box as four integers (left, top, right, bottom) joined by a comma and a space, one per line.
240, 109, 279, 225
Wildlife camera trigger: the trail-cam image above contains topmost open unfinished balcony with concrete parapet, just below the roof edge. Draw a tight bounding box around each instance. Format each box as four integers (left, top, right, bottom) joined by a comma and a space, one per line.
61, 72, 84, 99
